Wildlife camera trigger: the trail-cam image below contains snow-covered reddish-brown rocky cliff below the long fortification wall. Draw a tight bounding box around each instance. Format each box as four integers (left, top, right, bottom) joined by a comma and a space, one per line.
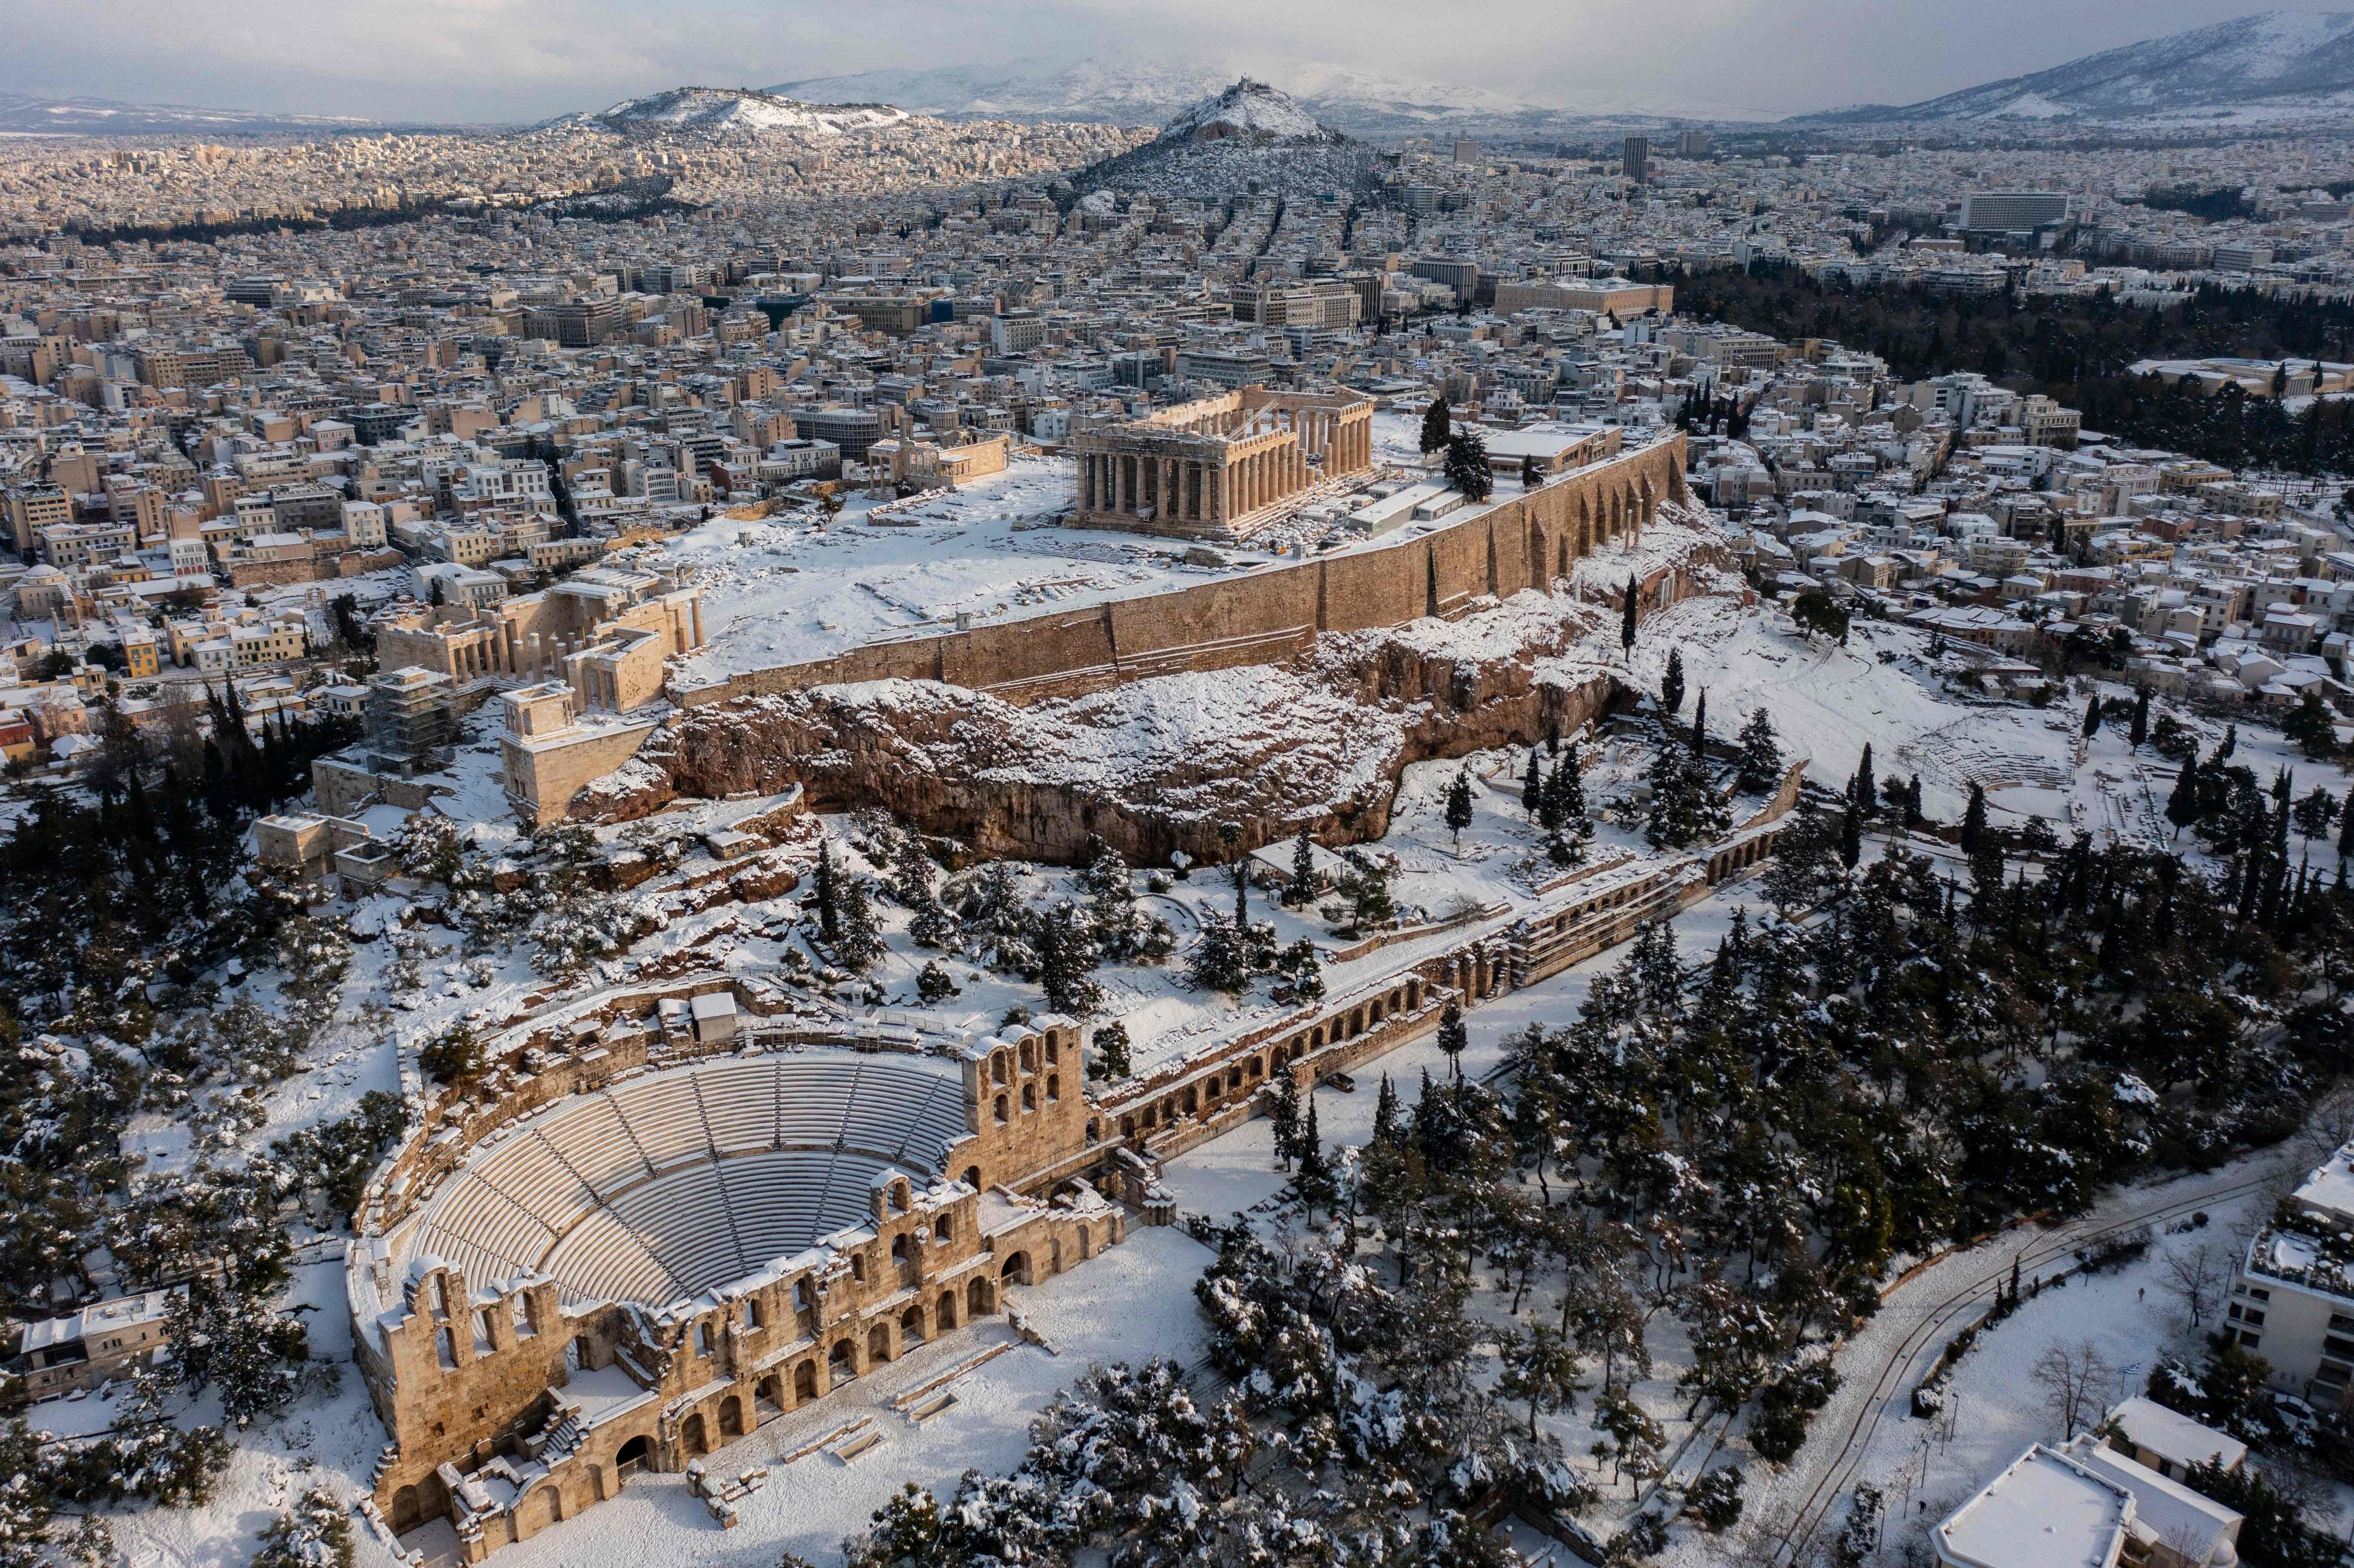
574, 532, 1737, 866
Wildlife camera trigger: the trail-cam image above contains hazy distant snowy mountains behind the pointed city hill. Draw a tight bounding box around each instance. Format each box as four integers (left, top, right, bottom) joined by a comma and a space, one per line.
770, 59, 1558, 137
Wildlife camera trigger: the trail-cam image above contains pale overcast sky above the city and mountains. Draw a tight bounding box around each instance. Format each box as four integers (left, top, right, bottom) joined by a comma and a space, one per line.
0, 0, 2297, 122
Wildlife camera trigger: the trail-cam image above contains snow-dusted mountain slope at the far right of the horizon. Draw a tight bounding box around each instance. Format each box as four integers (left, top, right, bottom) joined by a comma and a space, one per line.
1801, 12, 2354, 125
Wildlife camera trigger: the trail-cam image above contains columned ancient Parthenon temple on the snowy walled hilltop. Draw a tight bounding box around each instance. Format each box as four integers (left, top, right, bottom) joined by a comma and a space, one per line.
1071, 386, 1373, 541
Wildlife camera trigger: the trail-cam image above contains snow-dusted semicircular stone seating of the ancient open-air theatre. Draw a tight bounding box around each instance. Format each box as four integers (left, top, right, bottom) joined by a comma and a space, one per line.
410, 1052, 965, 1304
